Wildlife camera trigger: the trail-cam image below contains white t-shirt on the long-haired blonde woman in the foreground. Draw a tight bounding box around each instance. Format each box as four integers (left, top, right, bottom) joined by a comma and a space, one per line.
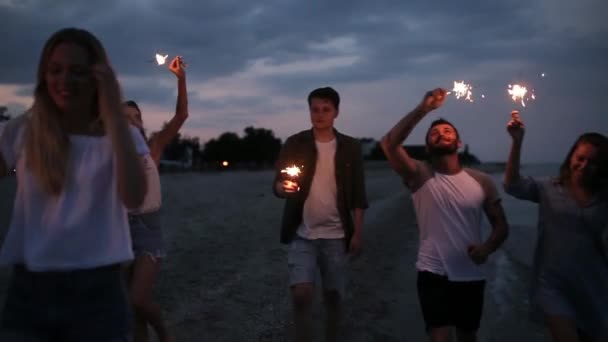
0, 117, 149, 271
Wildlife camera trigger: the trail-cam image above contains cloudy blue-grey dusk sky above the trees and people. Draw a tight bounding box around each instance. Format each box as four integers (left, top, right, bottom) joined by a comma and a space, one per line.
0, 0, 608, 162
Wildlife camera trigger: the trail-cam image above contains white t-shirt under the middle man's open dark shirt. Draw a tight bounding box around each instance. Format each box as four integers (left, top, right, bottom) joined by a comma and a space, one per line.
297, 139, 344, 240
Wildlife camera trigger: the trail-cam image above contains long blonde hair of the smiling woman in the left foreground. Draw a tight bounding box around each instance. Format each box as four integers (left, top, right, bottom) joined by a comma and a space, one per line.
24, 28, 108, 195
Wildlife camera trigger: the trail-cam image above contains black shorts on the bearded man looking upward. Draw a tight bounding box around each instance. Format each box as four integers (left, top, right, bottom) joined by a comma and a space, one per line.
417, 271, 486, 332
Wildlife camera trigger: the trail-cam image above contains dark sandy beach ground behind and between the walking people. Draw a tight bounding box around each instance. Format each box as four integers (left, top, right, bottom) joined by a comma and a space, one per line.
0, 165, 548, 342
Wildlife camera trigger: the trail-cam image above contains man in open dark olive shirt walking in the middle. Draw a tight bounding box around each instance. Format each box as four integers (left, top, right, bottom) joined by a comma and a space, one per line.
273, 87, 368, 341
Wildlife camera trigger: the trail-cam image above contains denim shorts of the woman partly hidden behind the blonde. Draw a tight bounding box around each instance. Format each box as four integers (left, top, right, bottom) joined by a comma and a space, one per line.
129, 211, 166, 258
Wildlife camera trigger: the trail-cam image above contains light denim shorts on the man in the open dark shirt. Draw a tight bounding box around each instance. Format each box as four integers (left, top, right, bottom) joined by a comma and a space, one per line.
287, 237, 346, 297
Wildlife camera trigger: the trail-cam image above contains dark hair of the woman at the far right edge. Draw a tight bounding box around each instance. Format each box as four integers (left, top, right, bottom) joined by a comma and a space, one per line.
558, 132, 608, 193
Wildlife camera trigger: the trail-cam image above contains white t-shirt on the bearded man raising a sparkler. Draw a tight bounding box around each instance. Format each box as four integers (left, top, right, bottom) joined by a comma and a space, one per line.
408, 162, 499, 281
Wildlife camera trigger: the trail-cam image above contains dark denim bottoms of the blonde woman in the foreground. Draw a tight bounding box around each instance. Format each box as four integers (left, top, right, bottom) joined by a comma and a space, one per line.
0, 264, 131, 342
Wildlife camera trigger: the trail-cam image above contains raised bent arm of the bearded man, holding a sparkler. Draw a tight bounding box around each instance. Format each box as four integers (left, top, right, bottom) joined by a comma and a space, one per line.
380, 88, 446, 178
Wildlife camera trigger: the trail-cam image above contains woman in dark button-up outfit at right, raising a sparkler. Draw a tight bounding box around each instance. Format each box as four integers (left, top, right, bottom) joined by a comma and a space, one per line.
505, 112, 608, 342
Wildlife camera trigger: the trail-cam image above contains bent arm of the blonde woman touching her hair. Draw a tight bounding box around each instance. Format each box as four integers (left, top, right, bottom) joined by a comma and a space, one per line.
94, 65, 147, 209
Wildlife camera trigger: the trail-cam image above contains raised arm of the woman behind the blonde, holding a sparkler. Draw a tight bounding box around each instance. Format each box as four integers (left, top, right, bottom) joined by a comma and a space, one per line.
149, 56, 188, 166
